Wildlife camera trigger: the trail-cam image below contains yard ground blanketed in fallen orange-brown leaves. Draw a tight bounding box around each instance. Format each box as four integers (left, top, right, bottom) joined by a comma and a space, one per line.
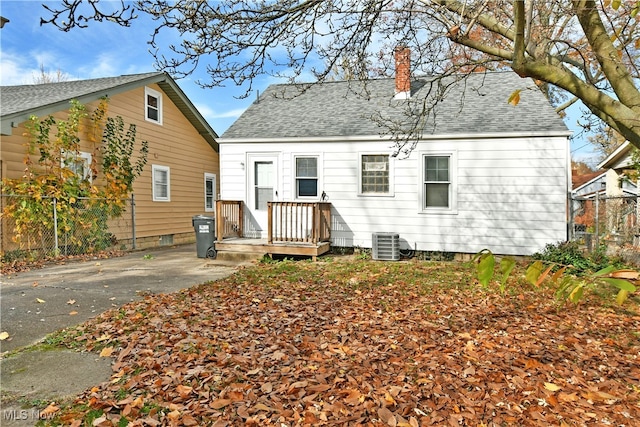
45, 260, 640, 427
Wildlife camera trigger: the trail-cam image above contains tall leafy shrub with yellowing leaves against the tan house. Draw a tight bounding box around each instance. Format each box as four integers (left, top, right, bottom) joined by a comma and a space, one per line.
2, 99, 148, 251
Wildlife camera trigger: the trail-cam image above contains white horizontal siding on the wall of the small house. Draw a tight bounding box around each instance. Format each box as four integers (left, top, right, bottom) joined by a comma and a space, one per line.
220, 136, 569, 255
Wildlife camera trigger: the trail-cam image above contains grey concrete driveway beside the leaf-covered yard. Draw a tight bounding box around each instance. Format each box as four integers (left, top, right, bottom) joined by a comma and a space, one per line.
0, 244, 246, 426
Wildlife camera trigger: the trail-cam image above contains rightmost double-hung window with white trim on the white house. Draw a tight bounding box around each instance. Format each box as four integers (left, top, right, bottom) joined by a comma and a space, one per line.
422, 154, 454, 211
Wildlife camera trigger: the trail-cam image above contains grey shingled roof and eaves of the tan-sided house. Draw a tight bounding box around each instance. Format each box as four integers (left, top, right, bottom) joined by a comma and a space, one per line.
0, 72, 218, 151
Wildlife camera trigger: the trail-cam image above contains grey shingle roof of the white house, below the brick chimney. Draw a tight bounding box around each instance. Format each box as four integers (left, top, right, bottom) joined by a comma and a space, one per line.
222, 72, 570, 139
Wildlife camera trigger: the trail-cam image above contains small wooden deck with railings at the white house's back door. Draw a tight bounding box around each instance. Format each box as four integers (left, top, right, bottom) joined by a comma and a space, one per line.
216, 200, 331, 261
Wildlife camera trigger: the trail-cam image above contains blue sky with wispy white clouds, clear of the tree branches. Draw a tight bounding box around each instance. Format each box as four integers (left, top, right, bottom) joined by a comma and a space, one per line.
0, 0, 598, 164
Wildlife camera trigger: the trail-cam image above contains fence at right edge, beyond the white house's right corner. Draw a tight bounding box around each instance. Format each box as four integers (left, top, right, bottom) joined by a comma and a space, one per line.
570, 193, 640, 251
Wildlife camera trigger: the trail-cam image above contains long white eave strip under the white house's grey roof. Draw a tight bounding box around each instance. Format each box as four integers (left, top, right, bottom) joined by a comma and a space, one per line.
218, 131, 572, 144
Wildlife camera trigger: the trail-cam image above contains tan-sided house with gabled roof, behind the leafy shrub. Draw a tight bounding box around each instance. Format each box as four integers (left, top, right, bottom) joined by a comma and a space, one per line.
0, 72, 220, 252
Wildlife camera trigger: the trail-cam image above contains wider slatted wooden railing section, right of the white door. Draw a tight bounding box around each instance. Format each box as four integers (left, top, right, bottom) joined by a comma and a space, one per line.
267, 202, 331, 244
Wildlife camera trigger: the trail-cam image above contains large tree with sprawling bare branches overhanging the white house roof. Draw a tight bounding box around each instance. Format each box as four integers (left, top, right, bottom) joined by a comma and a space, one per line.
41, 0, 640, 151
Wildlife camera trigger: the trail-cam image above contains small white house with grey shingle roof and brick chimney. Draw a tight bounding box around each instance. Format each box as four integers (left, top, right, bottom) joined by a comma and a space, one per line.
218, 50, 571, 255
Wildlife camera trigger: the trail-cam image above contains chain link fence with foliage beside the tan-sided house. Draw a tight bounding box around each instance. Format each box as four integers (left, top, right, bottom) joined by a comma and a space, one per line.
0, 194, 135, 262
